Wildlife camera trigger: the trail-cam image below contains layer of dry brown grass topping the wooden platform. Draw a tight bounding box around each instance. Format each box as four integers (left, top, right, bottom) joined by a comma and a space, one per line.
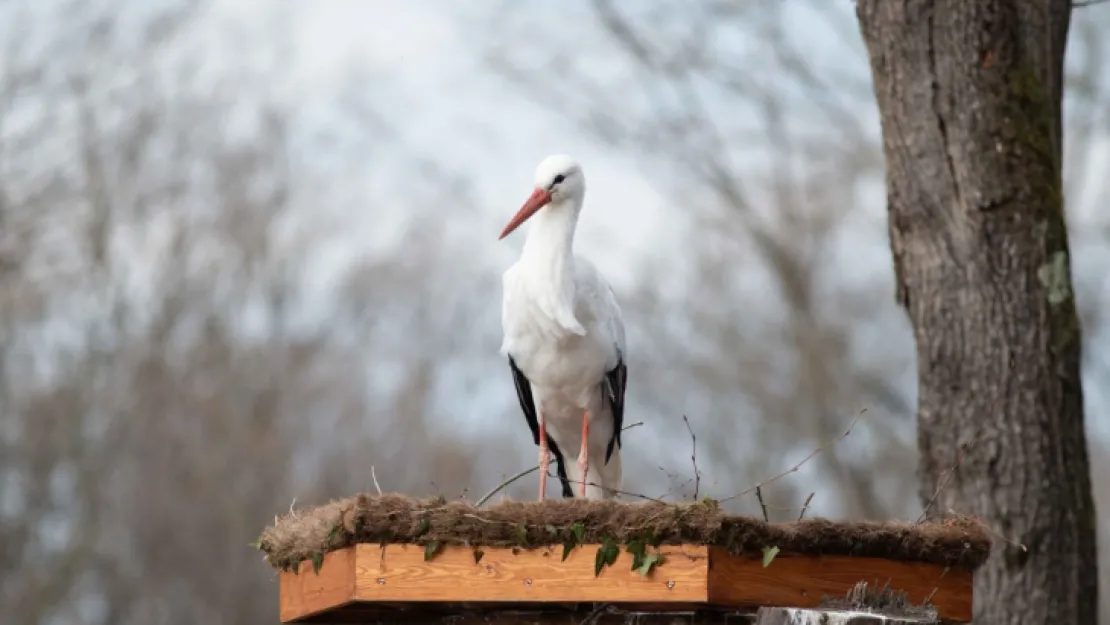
259, 494, 990, 568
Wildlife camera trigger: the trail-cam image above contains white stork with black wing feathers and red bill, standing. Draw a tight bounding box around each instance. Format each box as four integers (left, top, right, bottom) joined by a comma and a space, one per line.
498, 154, 627, 501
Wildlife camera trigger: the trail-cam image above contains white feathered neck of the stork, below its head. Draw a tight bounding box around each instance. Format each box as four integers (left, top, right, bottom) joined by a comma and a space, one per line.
521, 198, 582, 325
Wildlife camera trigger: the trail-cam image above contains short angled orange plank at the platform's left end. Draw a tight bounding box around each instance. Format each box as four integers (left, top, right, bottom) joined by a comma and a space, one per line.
279, 548, 356, 623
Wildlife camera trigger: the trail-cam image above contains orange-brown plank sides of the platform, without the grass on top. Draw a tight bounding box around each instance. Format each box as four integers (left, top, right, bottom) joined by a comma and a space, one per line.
280, 543, 972, 623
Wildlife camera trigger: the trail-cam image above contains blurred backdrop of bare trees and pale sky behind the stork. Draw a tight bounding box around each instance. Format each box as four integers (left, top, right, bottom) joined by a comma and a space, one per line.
0, 0, 1110, 625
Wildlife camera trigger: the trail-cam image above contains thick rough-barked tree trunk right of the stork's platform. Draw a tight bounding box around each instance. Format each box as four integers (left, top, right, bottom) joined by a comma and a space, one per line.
857, 0, 1098, 625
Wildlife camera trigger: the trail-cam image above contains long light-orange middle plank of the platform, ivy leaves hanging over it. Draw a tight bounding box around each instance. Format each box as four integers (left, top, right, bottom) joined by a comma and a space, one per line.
355, 544, 708, 603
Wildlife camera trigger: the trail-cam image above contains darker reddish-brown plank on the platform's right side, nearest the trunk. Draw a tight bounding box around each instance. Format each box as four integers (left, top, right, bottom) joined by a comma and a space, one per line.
709, 547, 971, 623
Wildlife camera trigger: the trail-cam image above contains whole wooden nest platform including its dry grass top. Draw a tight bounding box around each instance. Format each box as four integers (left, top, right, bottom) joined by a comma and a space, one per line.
259, 494, 990, 623
